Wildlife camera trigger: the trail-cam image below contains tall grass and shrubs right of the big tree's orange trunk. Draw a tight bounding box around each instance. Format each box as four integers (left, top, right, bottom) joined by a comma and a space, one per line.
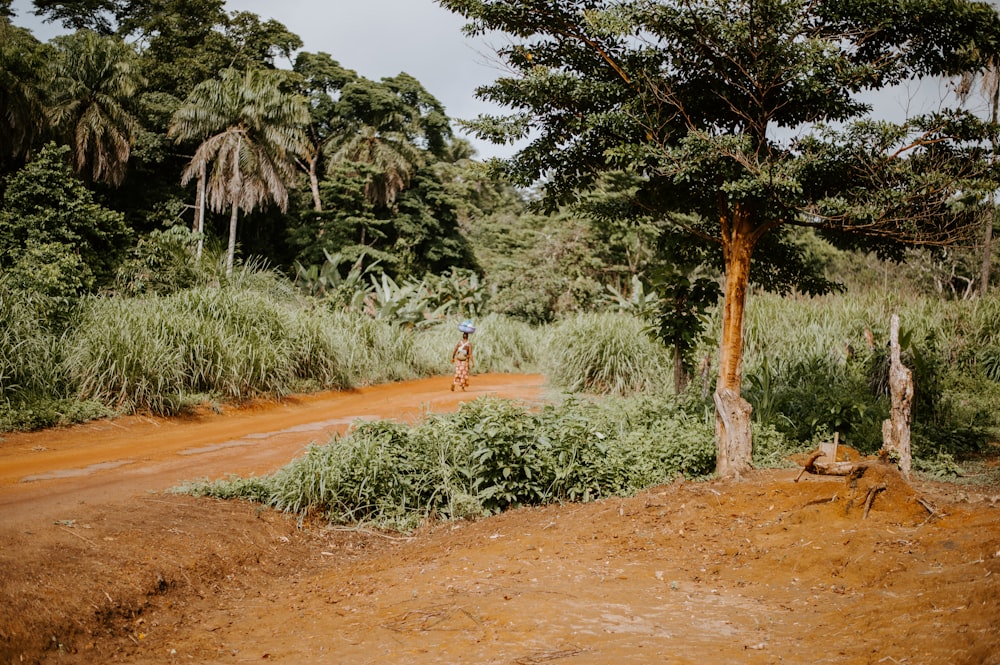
744, 294, 1000, 455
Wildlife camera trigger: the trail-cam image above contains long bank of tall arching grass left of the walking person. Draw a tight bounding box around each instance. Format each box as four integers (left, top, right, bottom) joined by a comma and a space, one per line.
64, 276, 430, 414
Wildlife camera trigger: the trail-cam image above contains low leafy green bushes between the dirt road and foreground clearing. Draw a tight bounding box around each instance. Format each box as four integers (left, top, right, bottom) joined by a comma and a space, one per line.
177, 397, 715, 529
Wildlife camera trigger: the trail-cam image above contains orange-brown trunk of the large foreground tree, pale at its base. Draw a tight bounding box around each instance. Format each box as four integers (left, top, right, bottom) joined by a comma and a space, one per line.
714, 209, 756, 478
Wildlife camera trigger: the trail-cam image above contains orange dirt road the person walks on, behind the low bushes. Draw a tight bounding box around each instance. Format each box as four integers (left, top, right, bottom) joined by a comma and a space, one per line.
0, 374, 543, 527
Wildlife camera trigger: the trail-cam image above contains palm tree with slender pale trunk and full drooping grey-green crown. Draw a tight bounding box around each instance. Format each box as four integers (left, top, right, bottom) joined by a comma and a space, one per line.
167, 69, 309, 274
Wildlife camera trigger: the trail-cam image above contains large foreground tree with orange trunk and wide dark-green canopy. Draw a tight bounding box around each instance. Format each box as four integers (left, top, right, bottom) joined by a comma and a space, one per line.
439, 0, 1000, 477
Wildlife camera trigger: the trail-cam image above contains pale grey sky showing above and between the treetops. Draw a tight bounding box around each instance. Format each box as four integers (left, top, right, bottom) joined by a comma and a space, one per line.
13, 0, 1000, 158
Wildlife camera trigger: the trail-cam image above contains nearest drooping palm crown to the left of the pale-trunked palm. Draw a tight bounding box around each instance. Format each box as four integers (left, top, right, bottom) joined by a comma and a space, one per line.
49, 30, 145, 185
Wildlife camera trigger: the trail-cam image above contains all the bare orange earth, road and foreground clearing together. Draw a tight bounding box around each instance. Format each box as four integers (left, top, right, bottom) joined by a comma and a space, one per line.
0, 375, 1000, 665
